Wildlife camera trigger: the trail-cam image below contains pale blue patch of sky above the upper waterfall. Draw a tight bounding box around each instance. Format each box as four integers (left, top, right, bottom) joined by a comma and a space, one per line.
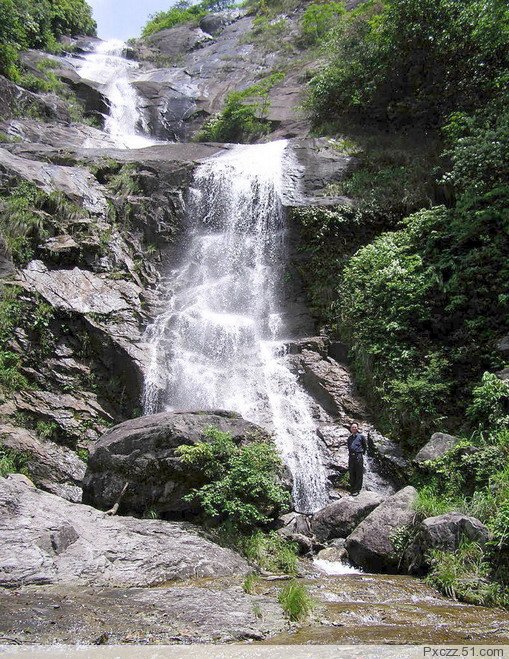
87, 0, 174, 41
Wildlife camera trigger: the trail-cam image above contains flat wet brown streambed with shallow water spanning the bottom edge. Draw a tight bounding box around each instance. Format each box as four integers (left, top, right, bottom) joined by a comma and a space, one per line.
0, 563, 509, 646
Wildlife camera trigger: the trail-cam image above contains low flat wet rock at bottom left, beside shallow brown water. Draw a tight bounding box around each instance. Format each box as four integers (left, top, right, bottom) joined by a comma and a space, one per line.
0, 579, 288, 654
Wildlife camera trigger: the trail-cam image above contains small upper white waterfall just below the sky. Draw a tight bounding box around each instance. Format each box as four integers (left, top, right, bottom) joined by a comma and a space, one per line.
76, 39, 157, 149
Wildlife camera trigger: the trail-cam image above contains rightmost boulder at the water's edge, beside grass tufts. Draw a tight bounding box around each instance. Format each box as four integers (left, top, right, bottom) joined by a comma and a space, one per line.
405, 513, 489, 573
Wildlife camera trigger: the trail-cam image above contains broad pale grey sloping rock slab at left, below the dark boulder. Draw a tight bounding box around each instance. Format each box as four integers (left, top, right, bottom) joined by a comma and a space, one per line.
0, 474, 248, 587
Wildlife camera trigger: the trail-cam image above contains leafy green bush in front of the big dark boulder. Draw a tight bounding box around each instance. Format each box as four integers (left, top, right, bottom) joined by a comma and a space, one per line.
177, 427, 290, 532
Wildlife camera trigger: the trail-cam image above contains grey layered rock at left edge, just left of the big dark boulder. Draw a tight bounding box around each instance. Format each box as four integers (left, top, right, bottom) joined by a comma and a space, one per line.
0, 423, 86, 503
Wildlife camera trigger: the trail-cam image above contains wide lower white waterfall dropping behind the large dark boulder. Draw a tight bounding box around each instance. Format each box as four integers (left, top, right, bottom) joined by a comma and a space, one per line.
141, 141, 328, 512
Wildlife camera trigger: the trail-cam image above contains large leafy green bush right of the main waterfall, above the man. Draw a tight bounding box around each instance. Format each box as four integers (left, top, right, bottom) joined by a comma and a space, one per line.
338, 105, 509, 442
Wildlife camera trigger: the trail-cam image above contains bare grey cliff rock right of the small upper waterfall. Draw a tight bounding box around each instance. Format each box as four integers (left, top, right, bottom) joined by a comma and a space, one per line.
129, 9, 309, 140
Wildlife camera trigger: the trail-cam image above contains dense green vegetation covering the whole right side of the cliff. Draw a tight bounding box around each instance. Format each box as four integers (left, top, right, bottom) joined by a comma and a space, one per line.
288, 0, 509, 605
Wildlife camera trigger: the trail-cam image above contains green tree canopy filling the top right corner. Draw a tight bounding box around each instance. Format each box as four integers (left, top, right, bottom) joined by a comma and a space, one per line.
310, 0, 509, 123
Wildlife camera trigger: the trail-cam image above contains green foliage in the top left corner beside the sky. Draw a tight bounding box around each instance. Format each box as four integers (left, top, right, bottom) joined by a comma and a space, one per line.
0, 0, 96, 81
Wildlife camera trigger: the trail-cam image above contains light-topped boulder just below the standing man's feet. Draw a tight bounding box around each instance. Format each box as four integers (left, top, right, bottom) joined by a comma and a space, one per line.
311, 490, 384, 542
